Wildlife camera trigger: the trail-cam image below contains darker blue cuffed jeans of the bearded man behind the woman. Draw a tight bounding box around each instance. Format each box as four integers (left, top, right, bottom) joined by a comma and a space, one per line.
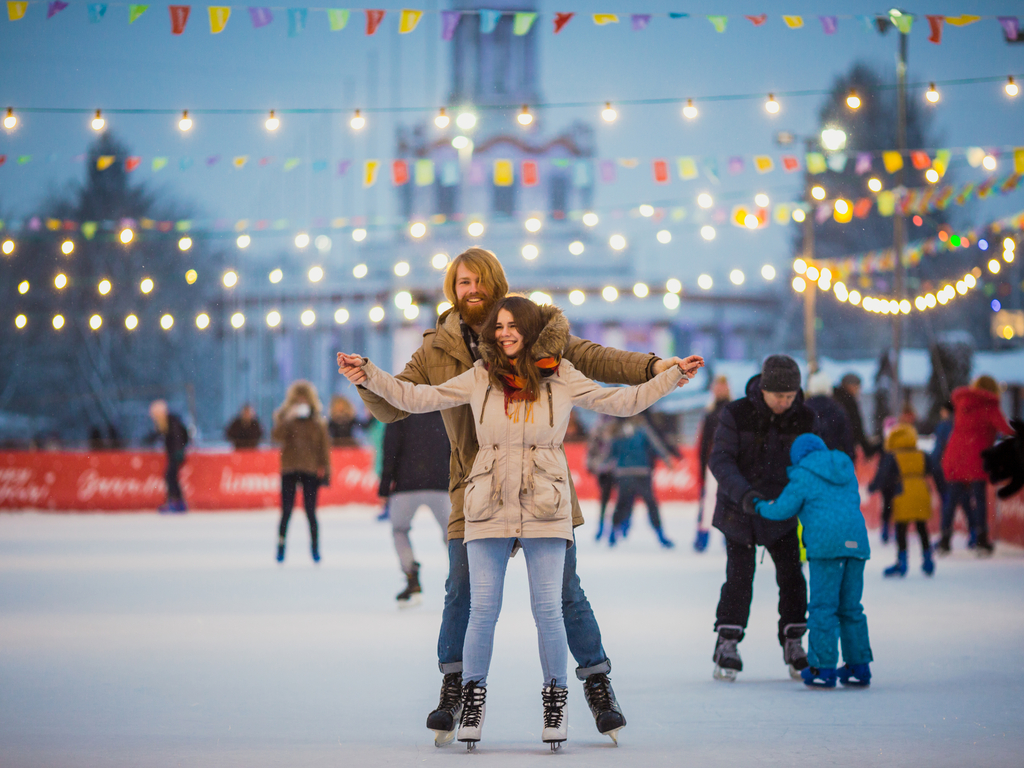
437, 539, 611, 680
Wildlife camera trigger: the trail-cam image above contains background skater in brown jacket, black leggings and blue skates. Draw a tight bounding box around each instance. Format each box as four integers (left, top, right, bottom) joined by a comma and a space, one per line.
270, 379, 331, 562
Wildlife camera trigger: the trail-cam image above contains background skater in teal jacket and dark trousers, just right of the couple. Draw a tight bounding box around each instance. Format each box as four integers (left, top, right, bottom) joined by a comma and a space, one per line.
608, 417, 679, 549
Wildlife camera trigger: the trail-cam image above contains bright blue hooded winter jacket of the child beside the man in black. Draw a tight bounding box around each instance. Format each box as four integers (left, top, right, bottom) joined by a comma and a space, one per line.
756, 434, 871, 560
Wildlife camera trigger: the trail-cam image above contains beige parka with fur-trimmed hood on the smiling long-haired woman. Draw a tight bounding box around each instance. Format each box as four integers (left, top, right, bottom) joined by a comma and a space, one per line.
364, 307, 682, 542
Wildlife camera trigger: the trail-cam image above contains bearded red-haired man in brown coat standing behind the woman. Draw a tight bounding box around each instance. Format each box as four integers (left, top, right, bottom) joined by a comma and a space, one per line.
344, 247, 696, 743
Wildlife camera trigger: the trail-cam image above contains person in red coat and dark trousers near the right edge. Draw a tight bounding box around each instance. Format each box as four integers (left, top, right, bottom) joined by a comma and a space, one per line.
937, 376, 1013, 553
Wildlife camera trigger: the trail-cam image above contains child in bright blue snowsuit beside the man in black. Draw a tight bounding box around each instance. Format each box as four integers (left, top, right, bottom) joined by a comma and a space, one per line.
756, 434, 872, 688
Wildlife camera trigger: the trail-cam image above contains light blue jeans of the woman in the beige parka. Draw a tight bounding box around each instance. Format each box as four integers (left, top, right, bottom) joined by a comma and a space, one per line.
462, 539, 568, 688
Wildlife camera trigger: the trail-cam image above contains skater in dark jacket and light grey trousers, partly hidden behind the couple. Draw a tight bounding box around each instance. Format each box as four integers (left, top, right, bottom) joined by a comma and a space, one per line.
378, 412, 452, 605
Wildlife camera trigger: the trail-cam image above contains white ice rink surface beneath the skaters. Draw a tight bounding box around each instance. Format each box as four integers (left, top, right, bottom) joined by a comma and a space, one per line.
0, 503, 1024, 768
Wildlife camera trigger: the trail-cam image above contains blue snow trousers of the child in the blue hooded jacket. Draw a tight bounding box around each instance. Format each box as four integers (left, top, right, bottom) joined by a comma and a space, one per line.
807, 557, 873, 670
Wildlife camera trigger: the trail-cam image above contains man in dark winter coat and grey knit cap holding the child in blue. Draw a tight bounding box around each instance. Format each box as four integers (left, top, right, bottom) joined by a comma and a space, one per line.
710, 354, 815, 680
